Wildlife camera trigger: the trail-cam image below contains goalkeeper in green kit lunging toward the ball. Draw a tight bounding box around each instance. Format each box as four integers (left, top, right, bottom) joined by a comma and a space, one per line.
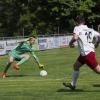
2, 36, 44, 78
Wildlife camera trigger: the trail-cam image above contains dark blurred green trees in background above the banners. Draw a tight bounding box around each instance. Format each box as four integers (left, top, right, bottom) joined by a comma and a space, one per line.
0, 0, 100, 36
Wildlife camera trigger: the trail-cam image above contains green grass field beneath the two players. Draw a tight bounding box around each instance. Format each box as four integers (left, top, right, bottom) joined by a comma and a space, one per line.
0, 48, 100, 100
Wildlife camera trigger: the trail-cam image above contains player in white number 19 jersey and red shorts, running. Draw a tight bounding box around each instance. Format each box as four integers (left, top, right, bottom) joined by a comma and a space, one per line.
63, 16, 100, 90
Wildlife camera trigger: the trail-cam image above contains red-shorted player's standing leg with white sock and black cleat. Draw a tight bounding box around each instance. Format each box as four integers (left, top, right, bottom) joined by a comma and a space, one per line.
63, 56, 84, 90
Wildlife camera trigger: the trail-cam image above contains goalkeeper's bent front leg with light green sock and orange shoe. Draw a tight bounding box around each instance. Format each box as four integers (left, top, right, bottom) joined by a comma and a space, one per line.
14, 54, 30, 70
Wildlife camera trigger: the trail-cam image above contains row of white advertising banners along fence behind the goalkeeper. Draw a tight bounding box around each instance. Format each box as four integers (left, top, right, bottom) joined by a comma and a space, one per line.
0, 36, 77, 55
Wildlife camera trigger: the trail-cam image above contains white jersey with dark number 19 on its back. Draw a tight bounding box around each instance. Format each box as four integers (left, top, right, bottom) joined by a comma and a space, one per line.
74, 25, 99, 56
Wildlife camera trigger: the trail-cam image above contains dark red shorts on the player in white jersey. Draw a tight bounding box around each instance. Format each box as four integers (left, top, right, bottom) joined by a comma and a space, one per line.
78, 52, 98, 69
